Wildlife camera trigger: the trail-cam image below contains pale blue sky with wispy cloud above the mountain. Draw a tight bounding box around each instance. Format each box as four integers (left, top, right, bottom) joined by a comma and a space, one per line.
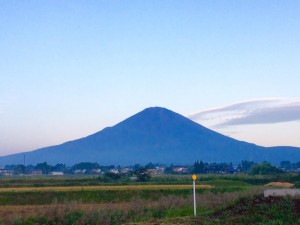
0, 0, 300, 155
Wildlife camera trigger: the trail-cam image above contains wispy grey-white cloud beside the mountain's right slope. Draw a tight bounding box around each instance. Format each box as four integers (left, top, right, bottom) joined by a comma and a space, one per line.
188, 98, 300, 128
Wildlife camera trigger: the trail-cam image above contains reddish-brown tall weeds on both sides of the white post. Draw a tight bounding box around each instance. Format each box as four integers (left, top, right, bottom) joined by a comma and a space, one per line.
0, 191, 260, 225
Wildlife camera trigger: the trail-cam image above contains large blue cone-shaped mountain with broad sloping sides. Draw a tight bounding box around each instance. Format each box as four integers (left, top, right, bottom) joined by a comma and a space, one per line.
0, 107, 300, 166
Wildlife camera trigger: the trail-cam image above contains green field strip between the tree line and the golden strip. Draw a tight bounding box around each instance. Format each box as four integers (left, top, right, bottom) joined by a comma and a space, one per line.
0, 174, 300, 188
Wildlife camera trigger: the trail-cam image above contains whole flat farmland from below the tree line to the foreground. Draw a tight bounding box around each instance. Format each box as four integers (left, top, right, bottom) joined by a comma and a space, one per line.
0, 175, 300, 225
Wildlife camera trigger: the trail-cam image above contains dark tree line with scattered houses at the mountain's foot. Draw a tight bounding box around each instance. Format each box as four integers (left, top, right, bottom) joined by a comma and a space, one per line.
4, 160, 300, 179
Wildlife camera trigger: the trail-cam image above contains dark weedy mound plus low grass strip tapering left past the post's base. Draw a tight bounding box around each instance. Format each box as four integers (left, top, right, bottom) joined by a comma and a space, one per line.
133, 195, 300, 225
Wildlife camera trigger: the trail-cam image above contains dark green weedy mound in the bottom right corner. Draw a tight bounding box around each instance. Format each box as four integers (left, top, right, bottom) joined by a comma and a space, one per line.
207, 195, 300, 225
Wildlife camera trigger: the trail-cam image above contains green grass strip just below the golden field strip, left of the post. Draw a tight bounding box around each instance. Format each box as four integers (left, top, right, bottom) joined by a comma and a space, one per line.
0, 189, 192, 205
